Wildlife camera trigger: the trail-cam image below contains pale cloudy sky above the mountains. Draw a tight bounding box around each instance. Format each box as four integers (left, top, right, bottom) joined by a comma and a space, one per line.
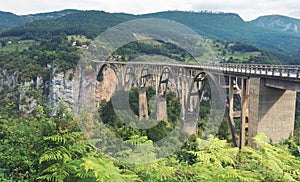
0, 0, 300, 21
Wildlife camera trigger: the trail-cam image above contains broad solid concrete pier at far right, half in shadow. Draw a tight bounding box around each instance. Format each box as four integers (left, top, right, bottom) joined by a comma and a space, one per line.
248, 77, 296, 147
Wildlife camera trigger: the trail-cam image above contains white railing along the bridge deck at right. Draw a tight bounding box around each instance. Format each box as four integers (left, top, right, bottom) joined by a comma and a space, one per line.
201, 63, 300, 78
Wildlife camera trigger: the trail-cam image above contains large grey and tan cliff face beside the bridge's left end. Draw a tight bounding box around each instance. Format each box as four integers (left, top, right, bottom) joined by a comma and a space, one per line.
50, 68, 118, 113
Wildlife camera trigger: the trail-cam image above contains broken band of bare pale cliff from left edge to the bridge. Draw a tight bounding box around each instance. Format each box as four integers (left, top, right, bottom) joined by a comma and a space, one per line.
0, 68, 118, 113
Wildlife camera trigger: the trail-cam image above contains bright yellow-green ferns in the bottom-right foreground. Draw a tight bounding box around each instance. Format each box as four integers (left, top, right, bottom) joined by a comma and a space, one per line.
176, 135, 299, 181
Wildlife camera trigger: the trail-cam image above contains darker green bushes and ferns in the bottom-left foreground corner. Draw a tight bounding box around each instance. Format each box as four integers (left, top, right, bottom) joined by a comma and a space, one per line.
0, 104, 117, 181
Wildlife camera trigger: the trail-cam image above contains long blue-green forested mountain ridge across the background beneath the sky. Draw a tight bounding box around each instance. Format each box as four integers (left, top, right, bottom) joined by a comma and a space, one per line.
0, 10, 300, 64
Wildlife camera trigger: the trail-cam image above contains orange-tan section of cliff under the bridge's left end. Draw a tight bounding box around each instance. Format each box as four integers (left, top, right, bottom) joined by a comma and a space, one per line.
95, 68, 118, 106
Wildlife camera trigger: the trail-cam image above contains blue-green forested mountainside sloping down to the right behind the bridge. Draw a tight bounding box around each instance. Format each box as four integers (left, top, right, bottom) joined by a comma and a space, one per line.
144, 11, 300, 64
